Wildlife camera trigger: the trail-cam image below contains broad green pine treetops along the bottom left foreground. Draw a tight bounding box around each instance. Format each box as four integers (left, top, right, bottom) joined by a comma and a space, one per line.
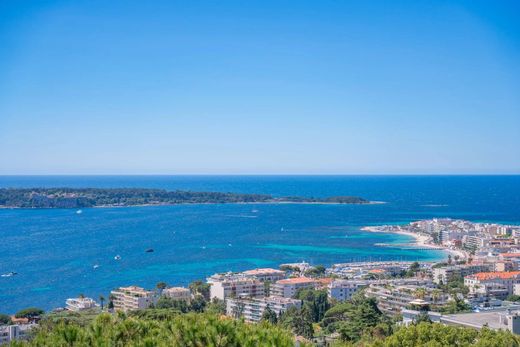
12, 313, 306, 347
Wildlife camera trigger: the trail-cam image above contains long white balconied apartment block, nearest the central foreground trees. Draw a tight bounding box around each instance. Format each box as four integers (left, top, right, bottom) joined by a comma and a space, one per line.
226, 296, 302, 322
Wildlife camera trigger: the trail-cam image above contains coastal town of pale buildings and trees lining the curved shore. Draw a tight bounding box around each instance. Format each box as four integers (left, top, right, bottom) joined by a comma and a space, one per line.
0, 218, 520, 345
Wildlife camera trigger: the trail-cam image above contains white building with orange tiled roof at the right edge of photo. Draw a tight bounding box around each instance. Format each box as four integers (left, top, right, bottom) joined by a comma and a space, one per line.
464, 271, 520, 295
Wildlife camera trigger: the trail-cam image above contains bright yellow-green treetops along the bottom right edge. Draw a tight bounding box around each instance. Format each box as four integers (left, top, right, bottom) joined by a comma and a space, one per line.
370, 322, 520, 347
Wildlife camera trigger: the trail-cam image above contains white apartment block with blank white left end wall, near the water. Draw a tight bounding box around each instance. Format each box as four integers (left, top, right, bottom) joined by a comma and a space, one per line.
207, 275, 265, 300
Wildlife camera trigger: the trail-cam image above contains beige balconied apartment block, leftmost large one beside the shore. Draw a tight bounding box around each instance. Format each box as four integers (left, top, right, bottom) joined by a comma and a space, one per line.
110, 286, 158, 311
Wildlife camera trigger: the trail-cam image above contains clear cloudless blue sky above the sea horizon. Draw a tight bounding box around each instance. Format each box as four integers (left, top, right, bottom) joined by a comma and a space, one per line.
0, 0, 520, 174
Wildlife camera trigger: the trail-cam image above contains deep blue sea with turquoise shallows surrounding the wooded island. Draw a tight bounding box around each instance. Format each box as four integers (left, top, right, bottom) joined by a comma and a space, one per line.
0, 176, 520, 313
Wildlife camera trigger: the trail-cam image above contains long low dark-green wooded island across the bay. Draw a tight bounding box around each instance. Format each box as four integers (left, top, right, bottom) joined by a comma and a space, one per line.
0, 188, 370, 208
